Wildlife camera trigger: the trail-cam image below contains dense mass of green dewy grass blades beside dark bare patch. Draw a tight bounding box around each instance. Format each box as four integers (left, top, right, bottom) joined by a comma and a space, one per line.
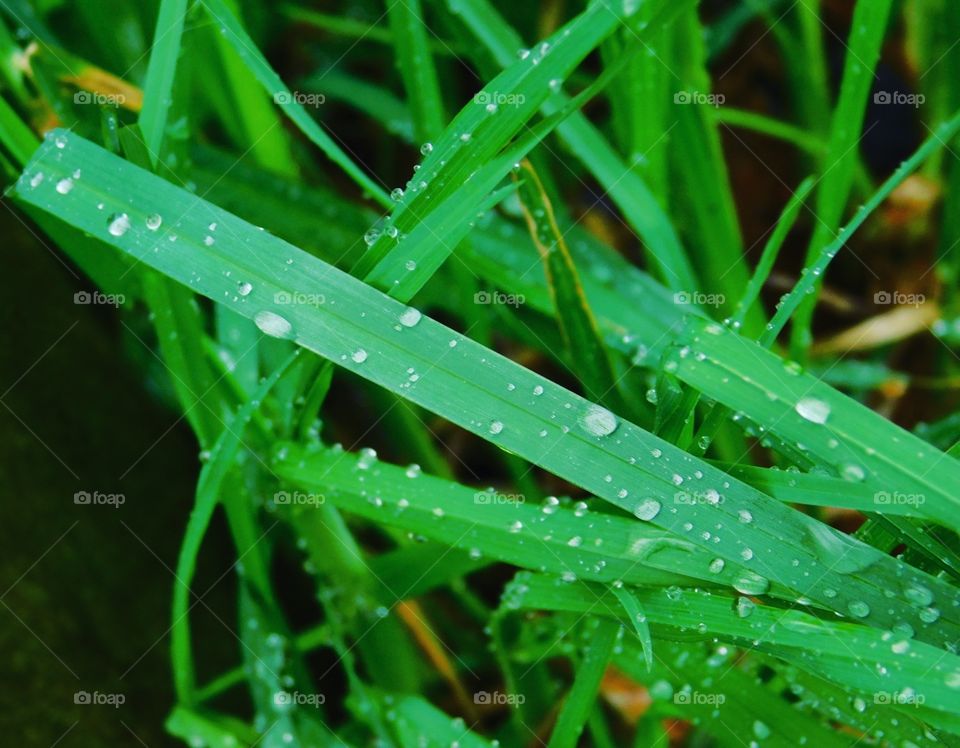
0, 0, 960, 748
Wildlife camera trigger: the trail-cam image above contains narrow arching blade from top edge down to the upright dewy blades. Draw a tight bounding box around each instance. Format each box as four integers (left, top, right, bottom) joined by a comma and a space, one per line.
203, 0, 391, 206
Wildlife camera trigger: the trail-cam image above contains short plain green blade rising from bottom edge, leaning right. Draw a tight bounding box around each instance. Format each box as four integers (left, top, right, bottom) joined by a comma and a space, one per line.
547, 619, 623, 748
